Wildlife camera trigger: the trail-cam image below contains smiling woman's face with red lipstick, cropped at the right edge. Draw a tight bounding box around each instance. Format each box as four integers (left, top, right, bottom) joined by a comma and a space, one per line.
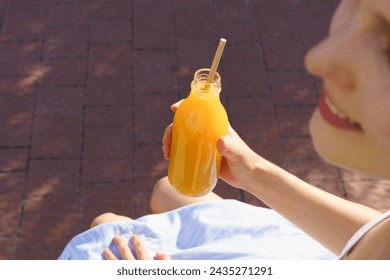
305, 0, 390, 179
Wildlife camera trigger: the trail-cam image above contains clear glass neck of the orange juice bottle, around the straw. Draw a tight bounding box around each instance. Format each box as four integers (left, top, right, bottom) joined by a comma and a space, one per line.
191, 68, 221, 97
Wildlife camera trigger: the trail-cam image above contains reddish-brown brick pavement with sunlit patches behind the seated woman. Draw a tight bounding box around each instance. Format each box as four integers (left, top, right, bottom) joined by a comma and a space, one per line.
0, 0, 390, 259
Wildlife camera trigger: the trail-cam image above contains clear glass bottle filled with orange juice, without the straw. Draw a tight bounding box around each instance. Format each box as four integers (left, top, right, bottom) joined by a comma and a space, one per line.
168, 69, 228, 196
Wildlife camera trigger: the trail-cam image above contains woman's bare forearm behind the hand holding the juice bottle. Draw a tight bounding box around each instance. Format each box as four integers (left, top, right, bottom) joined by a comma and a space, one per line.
244, 159, 381, 254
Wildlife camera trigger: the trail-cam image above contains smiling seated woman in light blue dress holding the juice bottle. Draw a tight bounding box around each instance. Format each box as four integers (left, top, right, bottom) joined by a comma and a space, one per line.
58, 0, 390, 259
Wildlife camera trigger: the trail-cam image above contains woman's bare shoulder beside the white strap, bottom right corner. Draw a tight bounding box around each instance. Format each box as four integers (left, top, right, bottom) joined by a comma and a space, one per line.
346, 211, 390, 260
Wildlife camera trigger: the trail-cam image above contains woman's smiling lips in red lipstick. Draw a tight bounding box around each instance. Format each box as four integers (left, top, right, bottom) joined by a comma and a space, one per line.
318, 91, 362, 131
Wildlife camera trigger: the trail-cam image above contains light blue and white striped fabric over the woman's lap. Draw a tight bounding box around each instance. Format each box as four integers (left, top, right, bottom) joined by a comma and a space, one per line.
59, 200, 337, 260
